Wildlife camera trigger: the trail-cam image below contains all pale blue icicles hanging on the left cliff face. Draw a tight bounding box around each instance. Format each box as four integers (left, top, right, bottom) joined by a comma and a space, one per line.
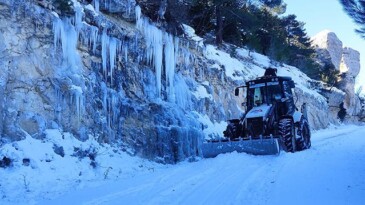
53, 0, 191, 124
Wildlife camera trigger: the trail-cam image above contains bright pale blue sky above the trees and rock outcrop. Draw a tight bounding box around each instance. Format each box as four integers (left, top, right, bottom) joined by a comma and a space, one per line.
284, 0, 365, 94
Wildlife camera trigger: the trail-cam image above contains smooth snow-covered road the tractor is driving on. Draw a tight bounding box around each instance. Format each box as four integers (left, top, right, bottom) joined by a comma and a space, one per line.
41, 126, 365, 204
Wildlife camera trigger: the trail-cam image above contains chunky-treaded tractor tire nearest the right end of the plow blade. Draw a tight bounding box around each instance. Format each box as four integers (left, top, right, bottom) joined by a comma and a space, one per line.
279, 118, 296, 152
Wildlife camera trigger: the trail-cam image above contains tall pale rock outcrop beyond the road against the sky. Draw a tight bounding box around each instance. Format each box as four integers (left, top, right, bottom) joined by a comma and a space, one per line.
312, 30, 361, 122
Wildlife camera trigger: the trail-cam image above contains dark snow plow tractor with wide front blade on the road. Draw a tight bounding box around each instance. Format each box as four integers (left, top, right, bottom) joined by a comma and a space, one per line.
202, 68, 311, 158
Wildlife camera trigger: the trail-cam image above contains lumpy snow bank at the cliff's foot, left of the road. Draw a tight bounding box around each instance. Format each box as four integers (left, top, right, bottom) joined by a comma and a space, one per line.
0, 130, 161, 204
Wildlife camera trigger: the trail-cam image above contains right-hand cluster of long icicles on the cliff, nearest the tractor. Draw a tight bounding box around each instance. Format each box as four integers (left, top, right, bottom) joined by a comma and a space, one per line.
135, 6, 196, 104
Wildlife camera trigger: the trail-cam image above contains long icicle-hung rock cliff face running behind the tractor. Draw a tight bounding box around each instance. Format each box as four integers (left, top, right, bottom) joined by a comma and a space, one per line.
0, 0, 344, 163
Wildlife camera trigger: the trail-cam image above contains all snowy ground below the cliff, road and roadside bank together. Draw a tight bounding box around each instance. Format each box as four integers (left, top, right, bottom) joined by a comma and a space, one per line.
0, 125, 365, 204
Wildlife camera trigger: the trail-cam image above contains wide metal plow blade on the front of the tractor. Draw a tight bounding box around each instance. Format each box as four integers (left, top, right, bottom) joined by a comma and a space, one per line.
202, 138, 280, 158
